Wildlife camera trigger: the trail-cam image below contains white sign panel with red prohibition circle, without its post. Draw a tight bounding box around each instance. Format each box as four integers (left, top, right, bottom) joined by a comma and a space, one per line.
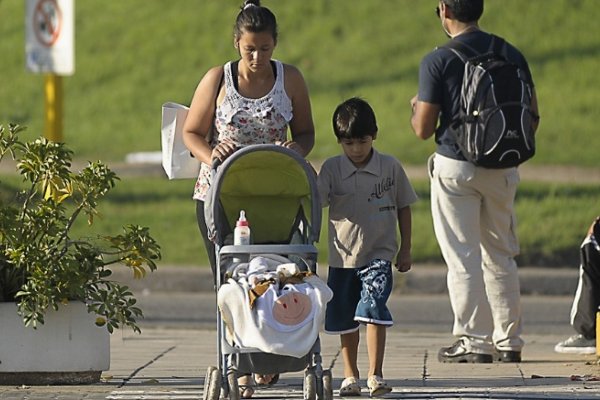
25, 0, 75, 75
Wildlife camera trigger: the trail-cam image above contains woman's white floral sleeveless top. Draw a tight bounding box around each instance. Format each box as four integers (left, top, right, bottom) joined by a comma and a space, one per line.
193, 60, 293, 201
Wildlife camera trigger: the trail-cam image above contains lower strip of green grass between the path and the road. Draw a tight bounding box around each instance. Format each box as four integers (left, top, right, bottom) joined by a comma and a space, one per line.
0, 176, 600, 266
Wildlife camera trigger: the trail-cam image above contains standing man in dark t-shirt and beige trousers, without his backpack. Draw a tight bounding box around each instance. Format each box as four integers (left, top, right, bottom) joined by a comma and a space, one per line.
410, 0, 538, 363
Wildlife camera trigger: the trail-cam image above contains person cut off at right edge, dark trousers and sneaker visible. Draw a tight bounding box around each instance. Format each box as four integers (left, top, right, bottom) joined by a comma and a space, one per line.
554, 217, 600, 354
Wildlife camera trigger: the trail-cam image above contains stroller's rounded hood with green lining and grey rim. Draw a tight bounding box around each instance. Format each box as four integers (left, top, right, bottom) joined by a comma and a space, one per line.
204, 144, 321, 245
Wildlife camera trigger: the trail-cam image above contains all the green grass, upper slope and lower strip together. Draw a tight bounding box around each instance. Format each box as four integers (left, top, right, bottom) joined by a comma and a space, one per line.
0, 0, 600, 265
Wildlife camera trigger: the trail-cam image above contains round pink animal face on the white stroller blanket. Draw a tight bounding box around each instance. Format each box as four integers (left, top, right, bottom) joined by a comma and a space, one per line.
256, 283, 317, 332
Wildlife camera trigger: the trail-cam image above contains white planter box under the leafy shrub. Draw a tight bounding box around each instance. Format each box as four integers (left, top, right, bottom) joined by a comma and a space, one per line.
0, 302, 110, 385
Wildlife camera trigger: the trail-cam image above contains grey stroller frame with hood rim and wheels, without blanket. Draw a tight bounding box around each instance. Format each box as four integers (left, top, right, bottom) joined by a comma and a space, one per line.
203, 145, 333, 400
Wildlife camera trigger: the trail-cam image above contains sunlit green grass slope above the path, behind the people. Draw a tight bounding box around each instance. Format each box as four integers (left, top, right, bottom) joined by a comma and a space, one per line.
0, 0, 600, 167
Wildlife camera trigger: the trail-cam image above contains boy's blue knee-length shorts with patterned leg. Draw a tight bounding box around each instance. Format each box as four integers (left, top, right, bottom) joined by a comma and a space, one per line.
325, 259, 394, 334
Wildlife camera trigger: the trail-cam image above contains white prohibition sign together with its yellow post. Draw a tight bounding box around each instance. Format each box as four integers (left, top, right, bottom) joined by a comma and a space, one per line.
25, 0, 75, 141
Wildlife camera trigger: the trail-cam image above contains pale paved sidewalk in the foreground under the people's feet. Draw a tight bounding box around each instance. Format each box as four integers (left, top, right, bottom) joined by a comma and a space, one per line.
0, 328, 600, 400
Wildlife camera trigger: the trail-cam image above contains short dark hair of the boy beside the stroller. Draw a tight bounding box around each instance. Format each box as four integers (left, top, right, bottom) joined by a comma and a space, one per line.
333, 97, 377, 140
